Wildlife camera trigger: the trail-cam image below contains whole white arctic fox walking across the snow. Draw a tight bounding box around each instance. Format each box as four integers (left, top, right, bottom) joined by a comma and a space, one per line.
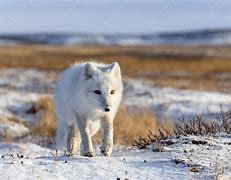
54, 62, 123, 157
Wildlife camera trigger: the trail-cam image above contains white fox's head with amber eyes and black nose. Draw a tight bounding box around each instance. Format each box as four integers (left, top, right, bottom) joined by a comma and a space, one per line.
84, 62, 122, 112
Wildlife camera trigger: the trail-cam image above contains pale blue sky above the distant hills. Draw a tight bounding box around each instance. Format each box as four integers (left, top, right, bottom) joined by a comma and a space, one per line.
0, 0, 231, 33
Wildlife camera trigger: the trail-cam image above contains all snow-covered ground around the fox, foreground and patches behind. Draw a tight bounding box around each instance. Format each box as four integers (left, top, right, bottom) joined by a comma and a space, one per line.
0, 69, 231, 179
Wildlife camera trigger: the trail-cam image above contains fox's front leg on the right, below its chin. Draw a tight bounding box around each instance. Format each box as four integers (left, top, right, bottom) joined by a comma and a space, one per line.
100, 118, 113, 156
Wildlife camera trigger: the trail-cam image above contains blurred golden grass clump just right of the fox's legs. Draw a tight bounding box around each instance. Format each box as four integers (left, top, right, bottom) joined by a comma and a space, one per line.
114, 106, 172, 145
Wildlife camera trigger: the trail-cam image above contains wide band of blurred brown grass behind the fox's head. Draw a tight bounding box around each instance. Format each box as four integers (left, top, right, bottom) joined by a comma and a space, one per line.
0, 45, 231, 91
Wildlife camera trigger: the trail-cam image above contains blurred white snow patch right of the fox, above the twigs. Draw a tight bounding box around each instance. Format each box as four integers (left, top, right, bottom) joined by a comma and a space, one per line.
124, 81, 231, 120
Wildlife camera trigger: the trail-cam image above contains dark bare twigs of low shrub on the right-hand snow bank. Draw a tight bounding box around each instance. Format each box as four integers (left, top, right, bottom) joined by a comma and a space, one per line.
133, 106, 231, 149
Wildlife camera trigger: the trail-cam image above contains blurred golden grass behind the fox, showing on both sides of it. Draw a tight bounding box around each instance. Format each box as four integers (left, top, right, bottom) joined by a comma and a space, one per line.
28, 97, 172, 146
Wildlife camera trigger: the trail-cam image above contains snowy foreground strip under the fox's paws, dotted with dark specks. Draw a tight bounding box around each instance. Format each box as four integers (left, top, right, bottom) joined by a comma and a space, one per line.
0, 136, 231, 180
